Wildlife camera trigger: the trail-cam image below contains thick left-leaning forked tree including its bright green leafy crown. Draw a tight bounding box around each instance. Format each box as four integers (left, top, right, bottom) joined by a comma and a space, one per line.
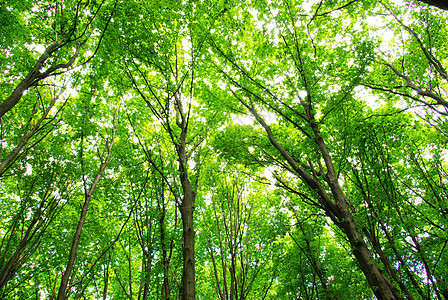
206, 2, 444, 299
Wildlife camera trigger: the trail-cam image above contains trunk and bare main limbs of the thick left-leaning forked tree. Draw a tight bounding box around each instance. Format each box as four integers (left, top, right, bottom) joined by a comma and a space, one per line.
207, 3, 401, 299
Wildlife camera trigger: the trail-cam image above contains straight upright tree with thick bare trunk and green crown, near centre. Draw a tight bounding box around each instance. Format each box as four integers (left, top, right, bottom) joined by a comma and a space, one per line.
98, 2, 229, 299
